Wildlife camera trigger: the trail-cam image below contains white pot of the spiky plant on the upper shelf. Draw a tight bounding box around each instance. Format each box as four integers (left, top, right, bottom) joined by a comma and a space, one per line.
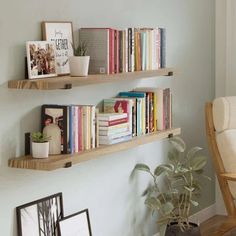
69, 56, 90, 76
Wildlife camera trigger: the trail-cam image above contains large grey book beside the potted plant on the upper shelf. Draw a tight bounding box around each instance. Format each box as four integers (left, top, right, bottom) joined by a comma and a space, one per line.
79, 28, 109, 74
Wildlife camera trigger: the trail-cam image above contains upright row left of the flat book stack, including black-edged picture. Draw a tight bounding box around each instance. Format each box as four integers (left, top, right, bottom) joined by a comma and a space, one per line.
41, 105, 99, 154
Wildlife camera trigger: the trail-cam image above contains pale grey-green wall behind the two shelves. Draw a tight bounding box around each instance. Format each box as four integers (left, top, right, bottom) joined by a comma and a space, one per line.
0, 0, 214, 236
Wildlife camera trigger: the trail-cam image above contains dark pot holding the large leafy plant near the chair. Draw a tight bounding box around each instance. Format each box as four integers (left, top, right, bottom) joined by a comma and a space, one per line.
165, 223, 201, 236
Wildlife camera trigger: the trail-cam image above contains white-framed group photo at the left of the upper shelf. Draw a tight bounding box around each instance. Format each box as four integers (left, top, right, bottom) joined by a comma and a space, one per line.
26, 41, 57, 79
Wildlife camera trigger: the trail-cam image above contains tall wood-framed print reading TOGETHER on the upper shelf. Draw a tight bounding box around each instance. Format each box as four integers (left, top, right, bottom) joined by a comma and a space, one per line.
42, 21, 73, 75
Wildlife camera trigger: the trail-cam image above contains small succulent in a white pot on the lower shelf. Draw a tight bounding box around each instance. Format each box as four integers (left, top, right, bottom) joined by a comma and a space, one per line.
31, 132, 50, 158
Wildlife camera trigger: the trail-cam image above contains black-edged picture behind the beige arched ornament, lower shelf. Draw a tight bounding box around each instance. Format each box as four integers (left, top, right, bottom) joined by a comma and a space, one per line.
41, 104, 68, 154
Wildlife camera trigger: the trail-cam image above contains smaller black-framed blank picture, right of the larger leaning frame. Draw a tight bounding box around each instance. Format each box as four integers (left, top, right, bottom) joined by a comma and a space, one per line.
59, 209, 92, 236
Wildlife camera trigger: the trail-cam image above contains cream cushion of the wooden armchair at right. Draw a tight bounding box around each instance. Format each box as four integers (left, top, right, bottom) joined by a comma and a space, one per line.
213, 97, 236, 199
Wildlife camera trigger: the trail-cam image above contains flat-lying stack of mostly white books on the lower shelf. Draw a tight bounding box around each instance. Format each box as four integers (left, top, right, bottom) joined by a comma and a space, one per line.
98, 113, 132, 145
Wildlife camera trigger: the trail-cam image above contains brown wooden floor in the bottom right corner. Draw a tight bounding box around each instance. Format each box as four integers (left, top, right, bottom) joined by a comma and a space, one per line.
200, 215, 236, 236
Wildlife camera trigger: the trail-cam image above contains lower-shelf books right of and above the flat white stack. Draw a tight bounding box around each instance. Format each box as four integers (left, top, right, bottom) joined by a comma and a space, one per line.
103, 88, 172, 136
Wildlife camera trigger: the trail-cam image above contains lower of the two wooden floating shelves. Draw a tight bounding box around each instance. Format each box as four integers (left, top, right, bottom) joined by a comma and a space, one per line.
8, 128, 181, 171
